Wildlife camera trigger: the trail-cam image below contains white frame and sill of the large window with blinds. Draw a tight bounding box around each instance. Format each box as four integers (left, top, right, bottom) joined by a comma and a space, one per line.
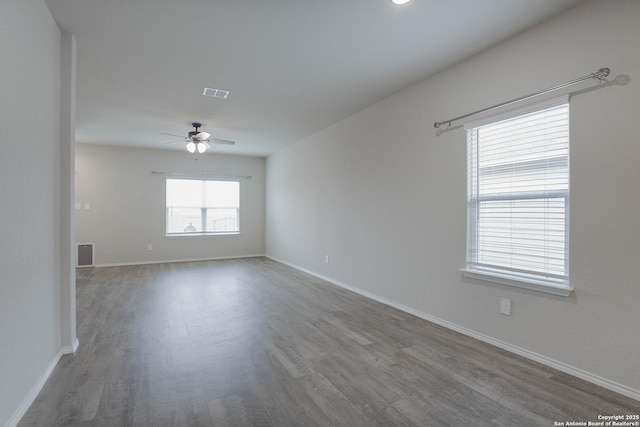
460, 95, 573, 296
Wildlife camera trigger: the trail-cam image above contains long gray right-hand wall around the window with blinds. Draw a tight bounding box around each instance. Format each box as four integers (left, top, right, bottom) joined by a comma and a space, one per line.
267, 0, 640, 396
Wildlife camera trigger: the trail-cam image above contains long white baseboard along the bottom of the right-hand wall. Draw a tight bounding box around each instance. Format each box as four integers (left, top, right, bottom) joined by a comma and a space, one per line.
266, 255, 640, 400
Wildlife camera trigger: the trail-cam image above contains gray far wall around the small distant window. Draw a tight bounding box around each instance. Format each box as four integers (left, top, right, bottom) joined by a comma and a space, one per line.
75, 144, 265, 265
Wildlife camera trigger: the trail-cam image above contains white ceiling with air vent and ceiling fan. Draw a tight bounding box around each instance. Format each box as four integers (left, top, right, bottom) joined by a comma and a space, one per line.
46, 0, 581, 156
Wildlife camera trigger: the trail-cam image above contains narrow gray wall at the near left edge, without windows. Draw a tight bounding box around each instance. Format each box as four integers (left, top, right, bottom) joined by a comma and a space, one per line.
0, 0, 61, 425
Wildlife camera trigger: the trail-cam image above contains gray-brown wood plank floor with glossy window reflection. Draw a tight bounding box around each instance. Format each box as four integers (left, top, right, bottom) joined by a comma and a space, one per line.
19, 258, 639, 427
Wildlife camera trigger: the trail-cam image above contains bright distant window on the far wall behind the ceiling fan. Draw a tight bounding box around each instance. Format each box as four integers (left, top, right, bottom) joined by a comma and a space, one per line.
166, 178, 240, 236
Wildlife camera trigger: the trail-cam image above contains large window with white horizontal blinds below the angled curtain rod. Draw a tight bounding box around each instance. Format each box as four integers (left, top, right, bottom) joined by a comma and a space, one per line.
463, 98, 572, 295
